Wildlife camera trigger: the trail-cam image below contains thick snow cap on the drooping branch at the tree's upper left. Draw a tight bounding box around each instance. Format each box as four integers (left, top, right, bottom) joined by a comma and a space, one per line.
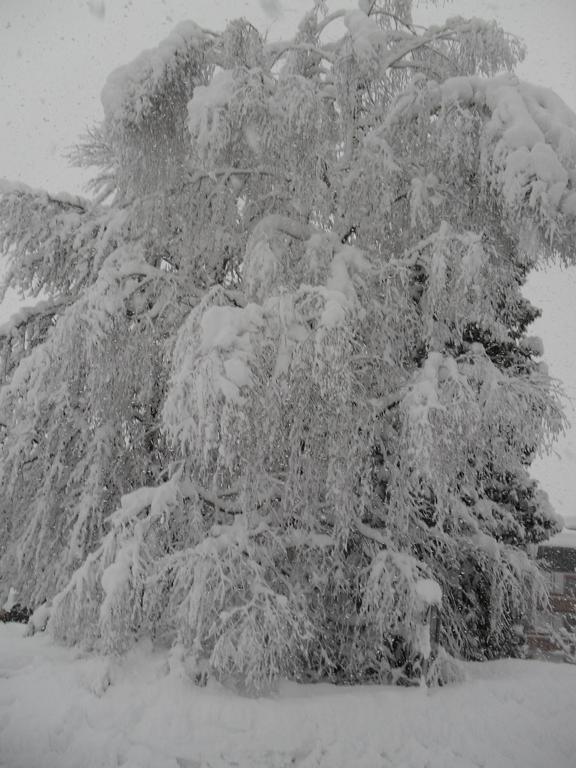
100, 21, 206, 123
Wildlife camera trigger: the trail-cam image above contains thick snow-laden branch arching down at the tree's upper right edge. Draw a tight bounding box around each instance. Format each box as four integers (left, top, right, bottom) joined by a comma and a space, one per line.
387, 75, 576, 258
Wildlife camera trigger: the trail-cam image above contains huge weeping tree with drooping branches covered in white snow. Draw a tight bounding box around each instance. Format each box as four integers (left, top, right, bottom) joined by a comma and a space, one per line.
0, 0, 576, 689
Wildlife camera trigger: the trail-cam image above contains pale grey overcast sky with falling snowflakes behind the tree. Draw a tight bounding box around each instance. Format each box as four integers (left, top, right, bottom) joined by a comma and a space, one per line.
0, 0, 576, 515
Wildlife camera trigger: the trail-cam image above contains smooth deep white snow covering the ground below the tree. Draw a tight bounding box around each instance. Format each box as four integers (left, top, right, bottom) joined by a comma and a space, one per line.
0, 624, 576, 768
